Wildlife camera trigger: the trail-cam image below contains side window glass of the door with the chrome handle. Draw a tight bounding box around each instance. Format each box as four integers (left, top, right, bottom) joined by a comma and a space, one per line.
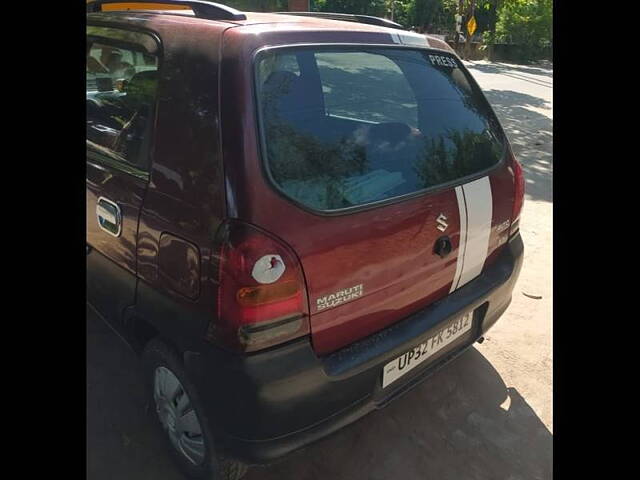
86, 27, 159, 170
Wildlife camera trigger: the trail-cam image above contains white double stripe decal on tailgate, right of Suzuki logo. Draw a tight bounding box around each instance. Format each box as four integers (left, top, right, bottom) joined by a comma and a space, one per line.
450, 177, 493, 292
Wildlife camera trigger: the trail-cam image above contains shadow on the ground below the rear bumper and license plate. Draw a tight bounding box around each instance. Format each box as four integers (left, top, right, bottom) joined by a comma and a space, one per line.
246, 348, 552, 480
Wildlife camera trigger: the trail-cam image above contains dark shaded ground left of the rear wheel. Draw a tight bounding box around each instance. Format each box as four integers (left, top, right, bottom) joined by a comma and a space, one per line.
86, 308, 184, 480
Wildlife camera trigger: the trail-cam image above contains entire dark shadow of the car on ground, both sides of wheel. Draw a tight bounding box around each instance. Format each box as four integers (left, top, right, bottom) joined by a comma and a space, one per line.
87, 312, 552, 480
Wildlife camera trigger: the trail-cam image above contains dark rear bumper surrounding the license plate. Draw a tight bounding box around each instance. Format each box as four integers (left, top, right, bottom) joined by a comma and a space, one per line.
185, 234, 524, 464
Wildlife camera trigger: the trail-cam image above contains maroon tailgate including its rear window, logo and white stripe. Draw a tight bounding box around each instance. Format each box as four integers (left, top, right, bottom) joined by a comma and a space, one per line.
258, 46, 513, 354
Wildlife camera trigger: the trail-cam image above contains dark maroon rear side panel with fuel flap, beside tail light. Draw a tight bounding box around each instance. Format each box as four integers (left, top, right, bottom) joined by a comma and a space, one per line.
94, 14, 234, 351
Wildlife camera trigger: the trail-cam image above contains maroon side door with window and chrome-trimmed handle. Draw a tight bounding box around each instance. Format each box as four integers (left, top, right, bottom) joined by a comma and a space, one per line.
86, 26, 158, 325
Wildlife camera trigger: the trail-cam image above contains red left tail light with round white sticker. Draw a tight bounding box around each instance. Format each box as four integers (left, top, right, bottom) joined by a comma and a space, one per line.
207, 220, 309, 352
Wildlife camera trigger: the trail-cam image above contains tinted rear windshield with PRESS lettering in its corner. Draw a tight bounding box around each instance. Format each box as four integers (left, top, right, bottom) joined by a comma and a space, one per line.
256, 47, 504, 210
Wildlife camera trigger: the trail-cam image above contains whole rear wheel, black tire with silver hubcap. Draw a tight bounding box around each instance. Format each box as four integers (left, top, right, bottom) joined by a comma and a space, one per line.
142, 339, 247, 480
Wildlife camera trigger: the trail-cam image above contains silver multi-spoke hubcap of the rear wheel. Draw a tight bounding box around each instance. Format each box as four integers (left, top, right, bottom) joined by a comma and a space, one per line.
153, 367, 205, 465
